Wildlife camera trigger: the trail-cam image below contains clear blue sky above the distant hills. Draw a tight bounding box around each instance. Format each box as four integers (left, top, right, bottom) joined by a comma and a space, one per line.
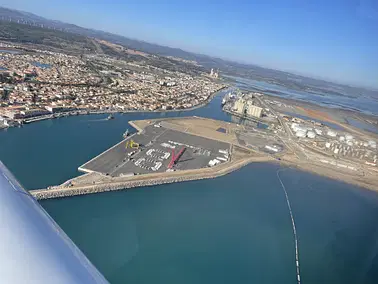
0, 0, 378, 89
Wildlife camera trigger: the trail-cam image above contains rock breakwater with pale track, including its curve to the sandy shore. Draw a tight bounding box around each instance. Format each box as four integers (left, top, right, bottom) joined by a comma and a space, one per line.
29, 156, 273, 200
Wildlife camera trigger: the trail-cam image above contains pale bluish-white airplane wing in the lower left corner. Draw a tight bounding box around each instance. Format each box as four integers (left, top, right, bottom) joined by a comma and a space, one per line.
0, 162, 108, 284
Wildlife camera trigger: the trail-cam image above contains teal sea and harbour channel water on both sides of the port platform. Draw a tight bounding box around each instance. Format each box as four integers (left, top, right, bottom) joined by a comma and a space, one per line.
0, 88, 378, 284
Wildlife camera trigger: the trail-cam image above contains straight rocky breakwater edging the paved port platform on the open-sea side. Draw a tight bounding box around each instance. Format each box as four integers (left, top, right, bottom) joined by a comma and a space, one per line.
29, 159, 260, 200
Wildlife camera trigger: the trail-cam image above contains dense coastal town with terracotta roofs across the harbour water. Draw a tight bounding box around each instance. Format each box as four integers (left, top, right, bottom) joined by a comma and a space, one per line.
0, 44, 225, 128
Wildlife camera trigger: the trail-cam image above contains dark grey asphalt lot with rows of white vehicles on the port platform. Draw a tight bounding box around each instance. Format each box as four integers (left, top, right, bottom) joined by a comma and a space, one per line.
79, 124, 230, 177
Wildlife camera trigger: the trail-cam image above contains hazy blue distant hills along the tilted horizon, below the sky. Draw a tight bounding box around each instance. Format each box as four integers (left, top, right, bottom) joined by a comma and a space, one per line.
0, 7, 378, 98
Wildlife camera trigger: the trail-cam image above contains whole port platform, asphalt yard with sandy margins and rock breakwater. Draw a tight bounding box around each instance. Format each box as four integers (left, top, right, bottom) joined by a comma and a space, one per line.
29, 117, 274, 199
